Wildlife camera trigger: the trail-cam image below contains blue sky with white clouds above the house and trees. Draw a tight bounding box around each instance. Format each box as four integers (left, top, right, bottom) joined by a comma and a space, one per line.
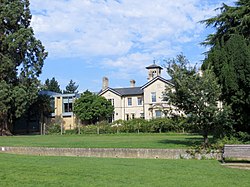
30, 0, 235, 92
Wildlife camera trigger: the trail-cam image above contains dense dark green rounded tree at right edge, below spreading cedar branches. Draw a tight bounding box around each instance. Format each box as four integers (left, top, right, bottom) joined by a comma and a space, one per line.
202, 35, 250, 132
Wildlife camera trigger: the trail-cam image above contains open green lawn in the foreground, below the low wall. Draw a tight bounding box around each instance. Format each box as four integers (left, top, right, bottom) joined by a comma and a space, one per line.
0, 153, 250, 187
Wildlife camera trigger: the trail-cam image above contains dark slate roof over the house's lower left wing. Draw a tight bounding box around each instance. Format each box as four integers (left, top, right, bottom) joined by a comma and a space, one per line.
99, 87, 143, 96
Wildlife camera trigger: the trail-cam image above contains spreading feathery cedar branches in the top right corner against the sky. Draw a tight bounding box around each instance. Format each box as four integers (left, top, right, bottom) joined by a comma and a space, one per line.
201, 0, 250, 46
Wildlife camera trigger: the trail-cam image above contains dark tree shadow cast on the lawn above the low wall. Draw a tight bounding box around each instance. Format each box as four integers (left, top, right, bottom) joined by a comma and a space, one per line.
158, 138, 209, 147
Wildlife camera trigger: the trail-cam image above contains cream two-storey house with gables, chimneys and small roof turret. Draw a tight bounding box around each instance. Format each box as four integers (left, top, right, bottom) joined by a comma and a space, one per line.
99, 63, 174, 121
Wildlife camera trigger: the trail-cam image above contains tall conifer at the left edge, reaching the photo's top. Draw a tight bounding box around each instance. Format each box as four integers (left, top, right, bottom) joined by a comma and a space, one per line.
0, 0, 47, 135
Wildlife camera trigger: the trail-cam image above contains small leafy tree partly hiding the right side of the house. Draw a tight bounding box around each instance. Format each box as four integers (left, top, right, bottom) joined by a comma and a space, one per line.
166, 54, 231, 146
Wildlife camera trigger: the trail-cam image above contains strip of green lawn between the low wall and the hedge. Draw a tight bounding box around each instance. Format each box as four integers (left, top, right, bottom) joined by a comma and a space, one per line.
0, 134, 207, 149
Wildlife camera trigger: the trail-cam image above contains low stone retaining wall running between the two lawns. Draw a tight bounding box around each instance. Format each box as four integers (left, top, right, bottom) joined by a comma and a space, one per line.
0, 147, 221, 159
